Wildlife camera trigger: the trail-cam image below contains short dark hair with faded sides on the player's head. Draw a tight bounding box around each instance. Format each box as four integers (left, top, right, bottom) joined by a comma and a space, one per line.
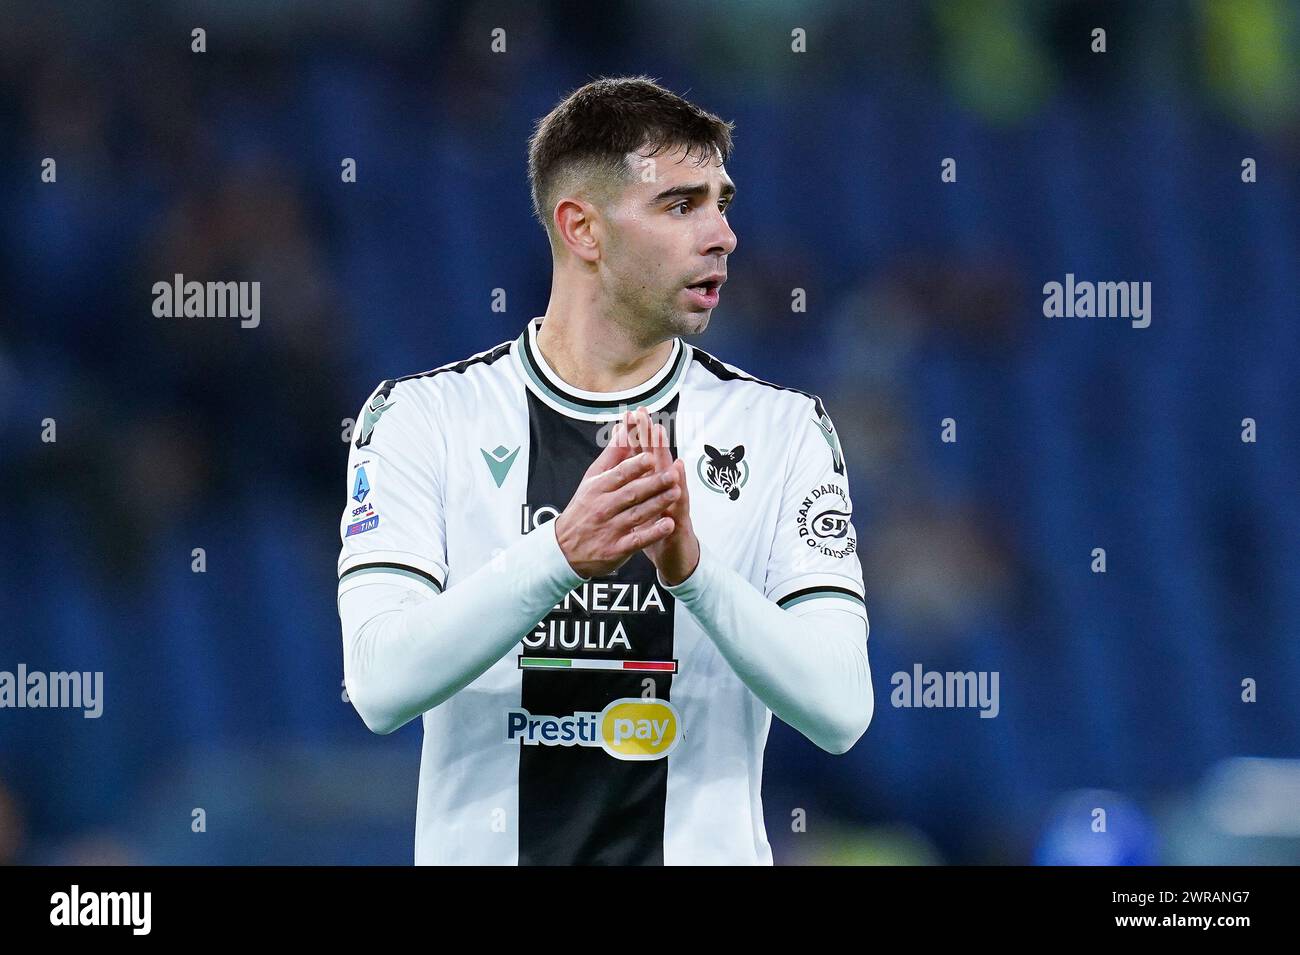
528, 77, 735, 242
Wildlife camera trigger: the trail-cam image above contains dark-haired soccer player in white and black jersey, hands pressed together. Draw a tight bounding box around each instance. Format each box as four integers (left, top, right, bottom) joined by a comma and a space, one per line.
338, 77, 874, 864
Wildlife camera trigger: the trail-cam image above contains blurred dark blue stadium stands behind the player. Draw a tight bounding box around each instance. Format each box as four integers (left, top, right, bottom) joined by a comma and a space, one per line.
0, 0, 1300, 864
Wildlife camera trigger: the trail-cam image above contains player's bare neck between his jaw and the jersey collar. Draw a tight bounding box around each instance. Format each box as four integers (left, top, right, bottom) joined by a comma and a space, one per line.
537, 281, 672, 391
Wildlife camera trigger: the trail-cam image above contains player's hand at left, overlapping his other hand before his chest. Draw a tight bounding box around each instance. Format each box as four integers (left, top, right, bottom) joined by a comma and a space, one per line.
555, 412, 681, 578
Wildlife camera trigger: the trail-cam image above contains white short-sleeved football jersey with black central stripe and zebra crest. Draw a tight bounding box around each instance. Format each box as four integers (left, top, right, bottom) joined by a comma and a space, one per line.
338, 318, 866, 864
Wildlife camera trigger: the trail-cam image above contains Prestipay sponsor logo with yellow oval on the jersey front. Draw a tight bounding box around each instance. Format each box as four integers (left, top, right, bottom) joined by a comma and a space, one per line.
506, 696, 681, 760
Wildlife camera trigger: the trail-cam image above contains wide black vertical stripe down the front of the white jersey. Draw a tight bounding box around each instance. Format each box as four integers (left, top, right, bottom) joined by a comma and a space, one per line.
514, 391, 683, 865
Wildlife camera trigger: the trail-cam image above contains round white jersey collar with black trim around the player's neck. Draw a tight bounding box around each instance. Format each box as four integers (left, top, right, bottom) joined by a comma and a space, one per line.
511, 317, 690, 421
